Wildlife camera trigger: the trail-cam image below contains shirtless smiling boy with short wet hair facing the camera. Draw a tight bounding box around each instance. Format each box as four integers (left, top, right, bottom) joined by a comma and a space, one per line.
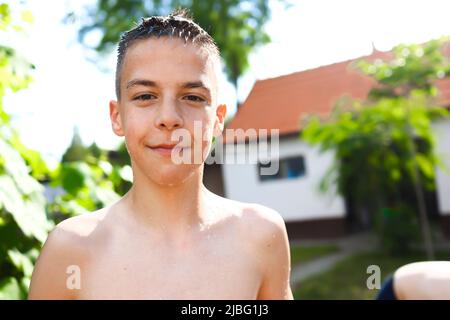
29, 12, 292, 300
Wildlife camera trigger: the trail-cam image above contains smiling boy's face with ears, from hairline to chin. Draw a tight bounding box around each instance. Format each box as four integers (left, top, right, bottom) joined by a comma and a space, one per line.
110, 37, 226, 185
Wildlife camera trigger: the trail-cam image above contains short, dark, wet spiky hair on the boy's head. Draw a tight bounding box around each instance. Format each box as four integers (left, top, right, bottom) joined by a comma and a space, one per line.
116, 9, 220, 99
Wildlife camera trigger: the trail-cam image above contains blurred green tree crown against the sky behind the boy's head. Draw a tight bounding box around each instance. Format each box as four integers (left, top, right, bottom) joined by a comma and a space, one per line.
72, 0, 288, 88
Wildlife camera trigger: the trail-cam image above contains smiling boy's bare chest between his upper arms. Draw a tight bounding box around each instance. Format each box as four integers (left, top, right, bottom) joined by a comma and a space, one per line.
80, 231, 261, 299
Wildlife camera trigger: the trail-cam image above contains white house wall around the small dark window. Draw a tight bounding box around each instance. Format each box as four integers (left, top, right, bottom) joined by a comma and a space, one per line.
222, 137, 345, 221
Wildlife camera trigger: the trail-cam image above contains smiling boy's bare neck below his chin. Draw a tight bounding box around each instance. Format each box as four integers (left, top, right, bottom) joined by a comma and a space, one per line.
120, 168, 209, 234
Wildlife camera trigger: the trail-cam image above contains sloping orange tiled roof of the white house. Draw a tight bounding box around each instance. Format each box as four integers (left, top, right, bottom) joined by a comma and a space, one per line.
223, 46, 450, 142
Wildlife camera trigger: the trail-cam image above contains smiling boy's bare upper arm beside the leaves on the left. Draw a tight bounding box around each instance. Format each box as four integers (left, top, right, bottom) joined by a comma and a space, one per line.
28, 219, 88, 299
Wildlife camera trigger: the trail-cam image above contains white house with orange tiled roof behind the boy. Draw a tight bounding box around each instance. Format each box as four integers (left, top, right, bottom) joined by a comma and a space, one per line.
205, 46, 450, 238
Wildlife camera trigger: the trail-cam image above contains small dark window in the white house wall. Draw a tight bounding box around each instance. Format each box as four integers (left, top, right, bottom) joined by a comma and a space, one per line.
257, 156, 306, 182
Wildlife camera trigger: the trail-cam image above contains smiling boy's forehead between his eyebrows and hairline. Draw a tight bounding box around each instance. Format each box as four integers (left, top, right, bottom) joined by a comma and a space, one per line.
122, 37, 217, 91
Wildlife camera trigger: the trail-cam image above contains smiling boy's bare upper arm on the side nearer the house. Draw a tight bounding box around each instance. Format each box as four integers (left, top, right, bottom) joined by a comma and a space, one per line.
248, 206, 293, 300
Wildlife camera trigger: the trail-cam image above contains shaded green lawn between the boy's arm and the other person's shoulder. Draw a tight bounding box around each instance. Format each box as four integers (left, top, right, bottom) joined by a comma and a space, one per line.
293, 251, 450, 300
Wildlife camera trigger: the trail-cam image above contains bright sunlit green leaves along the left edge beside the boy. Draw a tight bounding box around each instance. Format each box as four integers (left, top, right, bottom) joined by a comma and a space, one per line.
0, 2, 131, 299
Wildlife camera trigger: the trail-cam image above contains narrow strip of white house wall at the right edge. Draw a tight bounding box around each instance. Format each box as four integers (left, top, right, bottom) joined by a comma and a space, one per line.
433, 120, 450, 215
